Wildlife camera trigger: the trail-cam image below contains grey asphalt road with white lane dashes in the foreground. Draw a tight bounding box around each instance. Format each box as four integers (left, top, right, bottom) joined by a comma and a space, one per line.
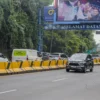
0, 66, 100, 100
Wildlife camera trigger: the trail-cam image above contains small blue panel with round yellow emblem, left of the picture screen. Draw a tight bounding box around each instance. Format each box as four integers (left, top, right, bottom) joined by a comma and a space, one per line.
44, 6, 55, 21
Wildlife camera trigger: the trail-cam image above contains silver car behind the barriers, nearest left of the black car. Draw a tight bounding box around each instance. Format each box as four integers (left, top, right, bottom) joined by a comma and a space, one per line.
50, 53, 68, 60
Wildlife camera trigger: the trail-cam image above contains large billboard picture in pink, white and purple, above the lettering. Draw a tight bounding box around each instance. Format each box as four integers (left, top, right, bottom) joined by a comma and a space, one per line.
56, 0, 100, 24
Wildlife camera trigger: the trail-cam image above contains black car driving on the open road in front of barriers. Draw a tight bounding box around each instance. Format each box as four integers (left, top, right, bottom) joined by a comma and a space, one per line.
66, 53, 94, 73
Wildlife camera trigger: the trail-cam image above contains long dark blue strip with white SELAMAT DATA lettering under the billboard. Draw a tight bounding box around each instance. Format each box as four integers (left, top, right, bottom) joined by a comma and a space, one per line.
44, 23, 100, 30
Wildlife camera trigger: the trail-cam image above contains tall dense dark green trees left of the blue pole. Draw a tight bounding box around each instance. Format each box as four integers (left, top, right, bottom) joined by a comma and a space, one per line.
0, 0, 39, 57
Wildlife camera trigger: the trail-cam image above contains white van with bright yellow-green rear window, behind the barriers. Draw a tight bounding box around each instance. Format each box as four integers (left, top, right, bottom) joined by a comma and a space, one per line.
12, 49, 41, 61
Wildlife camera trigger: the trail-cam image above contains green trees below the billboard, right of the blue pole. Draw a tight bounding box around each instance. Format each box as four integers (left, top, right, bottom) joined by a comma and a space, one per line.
44, 30, 95, 55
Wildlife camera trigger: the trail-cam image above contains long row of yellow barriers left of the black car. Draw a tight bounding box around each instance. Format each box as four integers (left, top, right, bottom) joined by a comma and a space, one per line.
0, 60, 67, 74
